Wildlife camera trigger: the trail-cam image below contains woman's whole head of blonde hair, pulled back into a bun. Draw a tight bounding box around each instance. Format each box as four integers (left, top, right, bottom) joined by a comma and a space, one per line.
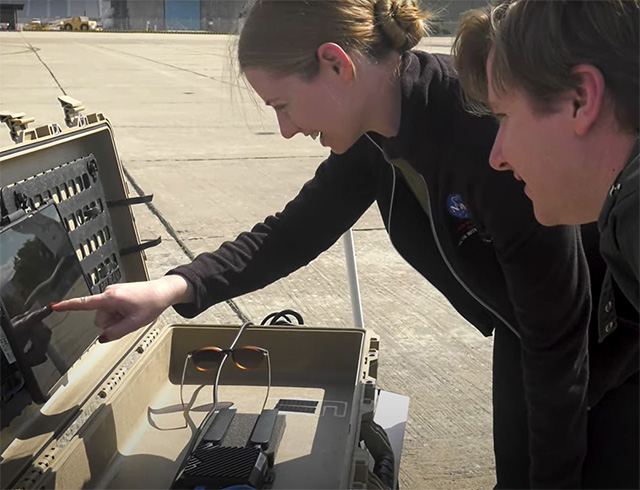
238, 0, 431, 79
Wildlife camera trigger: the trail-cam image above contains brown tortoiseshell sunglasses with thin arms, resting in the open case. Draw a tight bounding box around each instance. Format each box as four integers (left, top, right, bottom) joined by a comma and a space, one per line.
180, 345, 271, 423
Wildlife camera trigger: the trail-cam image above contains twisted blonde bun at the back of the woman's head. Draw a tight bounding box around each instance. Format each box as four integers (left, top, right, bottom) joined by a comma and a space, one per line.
374, 0, 428, 52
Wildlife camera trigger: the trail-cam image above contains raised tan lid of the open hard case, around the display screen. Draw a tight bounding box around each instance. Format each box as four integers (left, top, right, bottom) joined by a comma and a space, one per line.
0, 106, 151, 488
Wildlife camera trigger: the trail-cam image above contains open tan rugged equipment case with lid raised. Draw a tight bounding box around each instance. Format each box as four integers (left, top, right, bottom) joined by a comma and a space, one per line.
0, 97, 407, 489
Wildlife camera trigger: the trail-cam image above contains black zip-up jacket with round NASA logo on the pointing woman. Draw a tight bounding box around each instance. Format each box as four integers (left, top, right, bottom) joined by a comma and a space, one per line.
170, 52, 591, 488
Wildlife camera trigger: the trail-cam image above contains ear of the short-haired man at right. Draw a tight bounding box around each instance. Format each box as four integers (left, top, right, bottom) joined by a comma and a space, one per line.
571, 64, 605, 136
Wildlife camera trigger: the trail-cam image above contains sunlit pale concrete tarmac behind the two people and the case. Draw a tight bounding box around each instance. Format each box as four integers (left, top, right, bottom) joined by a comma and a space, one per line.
0, 32, 495, 489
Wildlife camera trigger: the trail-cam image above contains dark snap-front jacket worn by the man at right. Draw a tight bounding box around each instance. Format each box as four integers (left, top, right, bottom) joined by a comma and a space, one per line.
583, 139, 640, 406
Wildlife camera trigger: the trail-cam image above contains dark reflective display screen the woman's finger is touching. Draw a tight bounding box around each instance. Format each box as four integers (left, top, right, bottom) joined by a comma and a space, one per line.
0, 204, 98, 401
